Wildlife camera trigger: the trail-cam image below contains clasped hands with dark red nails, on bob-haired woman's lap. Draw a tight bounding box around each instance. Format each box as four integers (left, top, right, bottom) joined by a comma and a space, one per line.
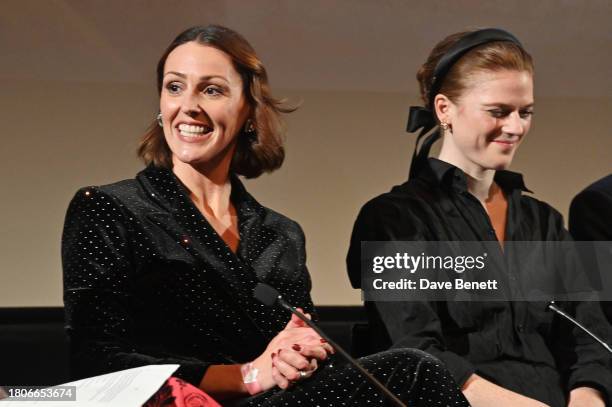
252, 308, 334, 391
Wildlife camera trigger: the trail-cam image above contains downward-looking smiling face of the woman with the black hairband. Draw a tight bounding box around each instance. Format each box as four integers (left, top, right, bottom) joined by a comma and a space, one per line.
434, 69, 533, 174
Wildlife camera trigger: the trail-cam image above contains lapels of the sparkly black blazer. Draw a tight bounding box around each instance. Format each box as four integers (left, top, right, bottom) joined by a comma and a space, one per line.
137, 166, 288, 335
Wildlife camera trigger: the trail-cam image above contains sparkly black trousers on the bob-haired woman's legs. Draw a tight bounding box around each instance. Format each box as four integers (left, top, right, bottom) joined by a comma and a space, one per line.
234, 349, 469, 407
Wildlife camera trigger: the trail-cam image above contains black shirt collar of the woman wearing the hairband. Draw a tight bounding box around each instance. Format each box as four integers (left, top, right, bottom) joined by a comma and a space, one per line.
428, 157, 532, 193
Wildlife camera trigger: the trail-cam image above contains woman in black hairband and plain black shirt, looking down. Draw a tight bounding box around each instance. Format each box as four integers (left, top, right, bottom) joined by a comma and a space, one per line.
347, 29, 612, 407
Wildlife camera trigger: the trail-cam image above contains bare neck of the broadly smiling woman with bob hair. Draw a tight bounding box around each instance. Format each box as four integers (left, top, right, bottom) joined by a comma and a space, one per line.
172, 144, 236, 218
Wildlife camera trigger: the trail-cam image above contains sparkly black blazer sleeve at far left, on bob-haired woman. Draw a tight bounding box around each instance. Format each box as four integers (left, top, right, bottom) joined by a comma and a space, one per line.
62, 187, 209, 386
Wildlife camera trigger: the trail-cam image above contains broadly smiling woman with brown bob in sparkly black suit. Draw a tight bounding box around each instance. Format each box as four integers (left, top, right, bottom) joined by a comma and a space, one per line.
62, 26, 467, 406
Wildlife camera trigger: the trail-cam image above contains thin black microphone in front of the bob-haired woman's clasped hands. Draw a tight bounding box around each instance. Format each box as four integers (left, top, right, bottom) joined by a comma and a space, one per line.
253, 283, 406, 407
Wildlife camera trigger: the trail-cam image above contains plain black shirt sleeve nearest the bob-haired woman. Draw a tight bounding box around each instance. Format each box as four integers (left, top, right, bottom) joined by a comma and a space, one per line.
346, 201, 475, 386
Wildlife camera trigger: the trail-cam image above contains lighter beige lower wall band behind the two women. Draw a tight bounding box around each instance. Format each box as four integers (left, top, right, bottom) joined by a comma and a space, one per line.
0, 81, 612, 307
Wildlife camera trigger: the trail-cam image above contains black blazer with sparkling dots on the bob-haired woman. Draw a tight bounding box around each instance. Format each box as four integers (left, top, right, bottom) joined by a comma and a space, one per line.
62, 166, 313, 385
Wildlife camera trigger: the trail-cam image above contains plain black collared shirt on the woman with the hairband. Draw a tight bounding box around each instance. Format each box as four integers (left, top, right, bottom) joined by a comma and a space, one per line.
347, 158, 612, 406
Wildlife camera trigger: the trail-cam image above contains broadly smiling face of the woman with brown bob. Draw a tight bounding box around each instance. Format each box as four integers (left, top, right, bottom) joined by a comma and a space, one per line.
160, 42, 250, 171
